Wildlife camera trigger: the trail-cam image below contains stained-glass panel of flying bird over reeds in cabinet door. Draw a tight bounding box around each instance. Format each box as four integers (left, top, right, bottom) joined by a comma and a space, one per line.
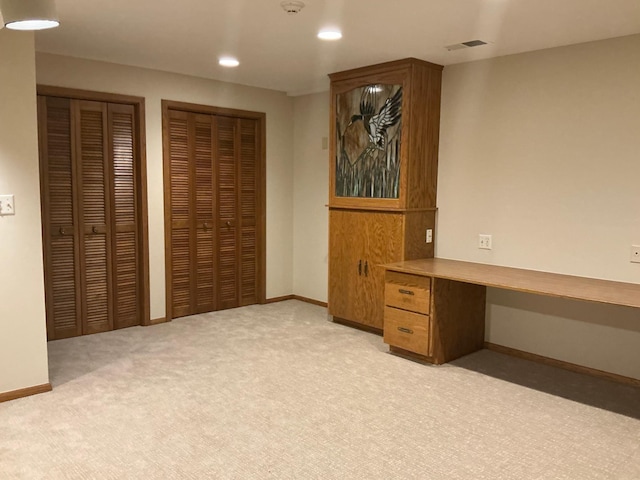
335, 84, 402, 198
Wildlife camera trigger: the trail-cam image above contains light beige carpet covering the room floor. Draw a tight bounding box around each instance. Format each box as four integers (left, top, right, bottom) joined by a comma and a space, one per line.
0, 301, 640, 480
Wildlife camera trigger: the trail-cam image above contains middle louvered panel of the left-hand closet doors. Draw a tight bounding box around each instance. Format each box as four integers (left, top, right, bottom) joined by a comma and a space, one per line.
75, 101, 113, 334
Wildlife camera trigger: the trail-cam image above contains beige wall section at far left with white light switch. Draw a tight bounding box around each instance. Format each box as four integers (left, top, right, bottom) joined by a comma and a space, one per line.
0, 30, 49, 393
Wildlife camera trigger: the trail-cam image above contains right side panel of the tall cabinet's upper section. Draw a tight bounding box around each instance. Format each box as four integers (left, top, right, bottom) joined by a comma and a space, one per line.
405, 65, 442, 208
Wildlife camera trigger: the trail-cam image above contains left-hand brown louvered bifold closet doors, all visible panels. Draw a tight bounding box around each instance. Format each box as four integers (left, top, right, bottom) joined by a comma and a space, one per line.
38, 94, 148, 340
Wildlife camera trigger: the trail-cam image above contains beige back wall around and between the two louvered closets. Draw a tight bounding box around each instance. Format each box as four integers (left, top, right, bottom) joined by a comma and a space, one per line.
36, 54, 293, 318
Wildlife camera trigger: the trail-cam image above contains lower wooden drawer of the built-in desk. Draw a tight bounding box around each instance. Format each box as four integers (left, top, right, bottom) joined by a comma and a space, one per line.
384, 307, 431, 357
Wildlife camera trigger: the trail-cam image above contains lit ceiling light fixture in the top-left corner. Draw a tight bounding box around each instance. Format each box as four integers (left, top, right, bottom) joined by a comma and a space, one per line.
0, 0, 60, 30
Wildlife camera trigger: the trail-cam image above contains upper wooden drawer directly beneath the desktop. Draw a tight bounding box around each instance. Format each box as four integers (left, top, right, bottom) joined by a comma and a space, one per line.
384, 271, 431, 315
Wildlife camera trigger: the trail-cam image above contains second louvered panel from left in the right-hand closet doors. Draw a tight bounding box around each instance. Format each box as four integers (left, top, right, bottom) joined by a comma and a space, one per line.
193, 115, 215, 313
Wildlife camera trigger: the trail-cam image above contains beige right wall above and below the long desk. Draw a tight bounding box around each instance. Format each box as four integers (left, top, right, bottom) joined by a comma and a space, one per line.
436, 35, 640, 378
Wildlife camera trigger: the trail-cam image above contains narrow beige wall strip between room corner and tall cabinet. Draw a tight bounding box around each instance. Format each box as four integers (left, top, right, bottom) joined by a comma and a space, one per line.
293, 93, 329, 302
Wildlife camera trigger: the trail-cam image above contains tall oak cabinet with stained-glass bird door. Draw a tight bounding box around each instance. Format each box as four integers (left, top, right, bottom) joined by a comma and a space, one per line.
328, 59, 442, 333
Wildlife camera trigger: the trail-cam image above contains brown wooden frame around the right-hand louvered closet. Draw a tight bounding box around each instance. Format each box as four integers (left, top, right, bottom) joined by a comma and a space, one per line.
162, 99, 267, 321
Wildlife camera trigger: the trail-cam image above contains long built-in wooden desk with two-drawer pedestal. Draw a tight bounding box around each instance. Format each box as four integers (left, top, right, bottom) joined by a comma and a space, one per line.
384, 258, 640, 382
